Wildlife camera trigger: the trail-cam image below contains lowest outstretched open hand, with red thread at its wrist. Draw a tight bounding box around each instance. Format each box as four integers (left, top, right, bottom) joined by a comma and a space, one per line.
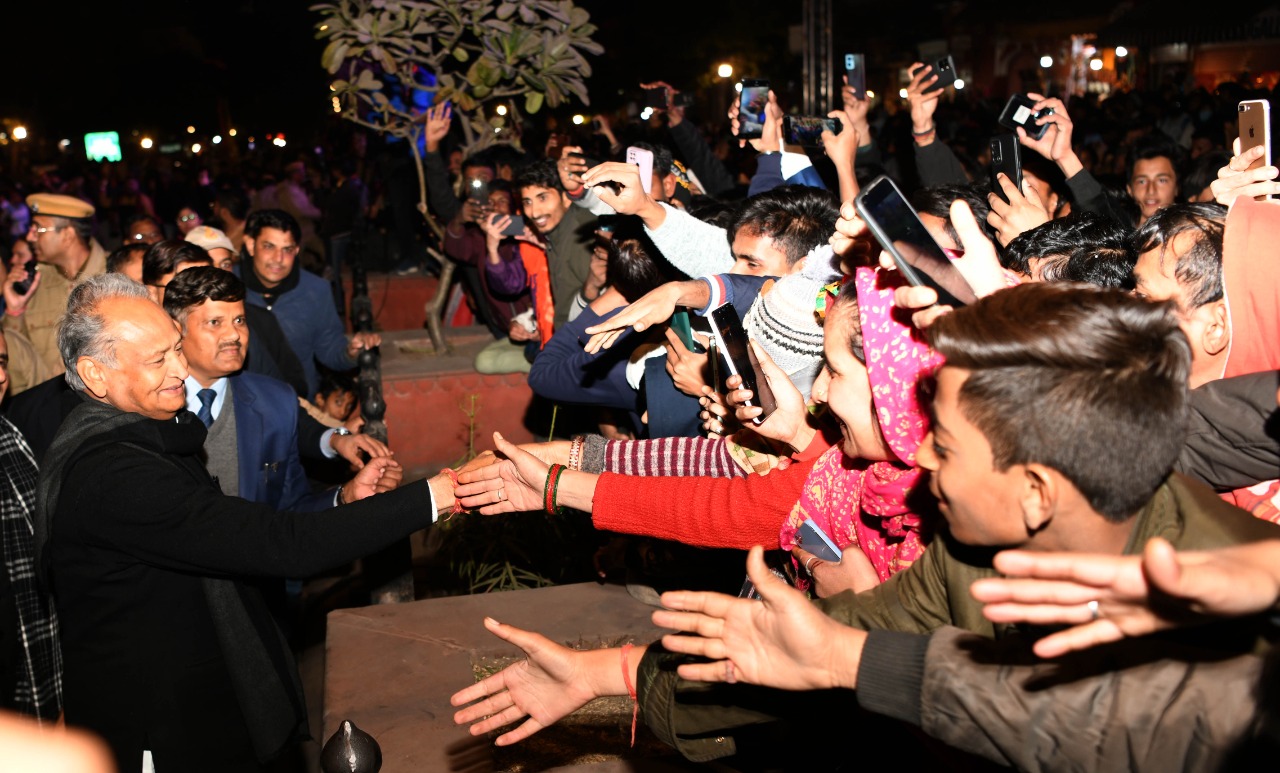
449, 617, 609, 746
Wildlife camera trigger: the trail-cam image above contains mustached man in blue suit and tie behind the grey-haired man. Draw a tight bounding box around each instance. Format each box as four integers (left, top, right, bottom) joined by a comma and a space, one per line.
164, 266, 355, 511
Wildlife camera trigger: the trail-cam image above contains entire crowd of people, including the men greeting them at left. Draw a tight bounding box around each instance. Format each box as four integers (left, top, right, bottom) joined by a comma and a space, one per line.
0, 48, 1280, 773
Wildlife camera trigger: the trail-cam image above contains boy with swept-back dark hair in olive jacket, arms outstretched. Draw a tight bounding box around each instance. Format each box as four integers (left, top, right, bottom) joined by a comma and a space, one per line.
454, 283, 1280, 767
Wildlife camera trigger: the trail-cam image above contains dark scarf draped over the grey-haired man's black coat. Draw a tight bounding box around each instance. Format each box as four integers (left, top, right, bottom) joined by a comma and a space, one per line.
35, 396, 307, 763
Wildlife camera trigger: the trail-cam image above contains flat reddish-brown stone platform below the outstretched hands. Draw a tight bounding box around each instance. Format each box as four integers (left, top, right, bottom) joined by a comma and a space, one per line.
324, 584, 701, 773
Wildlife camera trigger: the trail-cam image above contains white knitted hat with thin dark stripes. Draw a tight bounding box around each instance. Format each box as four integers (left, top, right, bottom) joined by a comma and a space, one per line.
742, 244, 840, 399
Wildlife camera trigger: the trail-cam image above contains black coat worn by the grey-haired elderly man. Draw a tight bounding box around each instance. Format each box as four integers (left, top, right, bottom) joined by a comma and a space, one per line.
42, 401, 433, 772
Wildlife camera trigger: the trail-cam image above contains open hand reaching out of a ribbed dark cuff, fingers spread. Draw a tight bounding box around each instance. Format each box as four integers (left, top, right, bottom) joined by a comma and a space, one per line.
653, 545, 867, 690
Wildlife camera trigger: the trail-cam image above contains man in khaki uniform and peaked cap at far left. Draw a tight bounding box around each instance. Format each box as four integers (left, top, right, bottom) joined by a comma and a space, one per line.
4, 193, 106, 375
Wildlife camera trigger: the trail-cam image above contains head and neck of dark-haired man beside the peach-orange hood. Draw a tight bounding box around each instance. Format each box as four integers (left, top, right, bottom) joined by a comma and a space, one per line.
1133, 203, 1231, 387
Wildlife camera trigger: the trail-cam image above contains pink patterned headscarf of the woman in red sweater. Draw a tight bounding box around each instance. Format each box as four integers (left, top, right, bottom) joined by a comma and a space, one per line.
781, 267, 942, 582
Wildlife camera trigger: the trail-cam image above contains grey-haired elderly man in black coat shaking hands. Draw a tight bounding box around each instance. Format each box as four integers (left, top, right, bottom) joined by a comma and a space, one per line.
36, 275, 473, 773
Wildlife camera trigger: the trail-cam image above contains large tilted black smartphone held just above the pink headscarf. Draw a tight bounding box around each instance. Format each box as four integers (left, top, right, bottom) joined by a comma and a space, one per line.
854, 175, 978, 308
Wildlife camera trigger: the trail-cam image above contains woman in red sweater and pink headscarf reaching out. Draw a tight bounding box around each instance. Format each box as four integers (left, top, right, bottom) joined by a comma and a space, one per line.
457, 269, 938, 595
